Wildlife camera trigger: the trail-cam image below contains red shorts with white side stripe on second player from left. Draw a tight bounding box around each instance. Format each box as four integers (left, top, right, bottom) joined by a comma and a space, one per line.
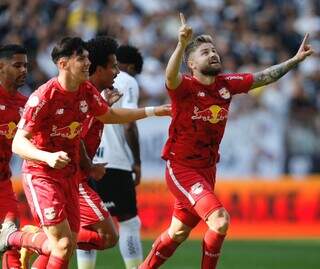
22, 174, 80, 233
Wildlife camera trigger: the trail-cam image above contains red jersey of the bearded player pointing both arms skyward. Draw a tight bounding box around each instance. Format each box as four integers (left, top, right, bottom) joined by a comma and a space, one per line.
162, 74, 253, 168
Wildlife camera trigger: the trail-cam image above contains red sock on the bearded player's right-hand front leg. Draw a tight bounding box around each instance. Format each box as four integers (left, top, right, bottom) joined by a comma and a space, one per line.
201, 230, 226, 269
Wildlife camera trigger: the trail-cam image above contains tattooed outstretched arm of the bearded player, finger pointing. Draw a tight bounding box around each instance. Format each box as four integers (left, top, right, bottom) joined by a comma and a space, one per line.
251, 34, 313, 89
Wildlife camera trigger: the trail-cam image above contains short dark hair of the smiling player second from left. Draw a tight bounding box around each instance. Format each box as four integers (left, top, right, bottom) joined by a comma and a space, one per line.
51, 37, 86, 63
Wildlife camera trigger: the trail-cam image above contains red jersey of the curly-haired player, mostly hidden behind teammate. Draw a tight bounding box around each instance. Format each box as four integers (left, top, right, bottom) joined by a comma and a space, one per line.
80, 117, 104, 182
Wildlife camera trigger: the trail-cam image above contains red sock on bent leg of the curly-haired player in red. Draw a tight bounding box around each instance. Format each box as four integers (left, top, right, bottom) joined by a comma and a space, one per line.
77, 228, 106, 250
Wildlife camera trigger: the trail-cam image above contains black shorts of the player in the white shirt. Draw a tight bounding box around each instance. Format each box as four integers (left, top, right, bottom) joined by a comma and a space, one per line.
90, 168, 138, 218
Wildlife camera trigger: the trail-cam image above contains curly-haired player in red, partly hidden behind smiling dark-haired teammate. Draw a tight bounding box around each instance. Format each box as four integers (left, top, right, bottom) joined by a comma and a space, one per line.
77, 36, 119, 269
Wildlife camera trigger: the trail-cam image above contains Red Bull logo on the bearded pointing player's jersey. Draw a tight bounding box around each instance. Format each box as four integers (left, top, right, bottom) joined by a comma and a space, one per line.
191, 105, 228, 124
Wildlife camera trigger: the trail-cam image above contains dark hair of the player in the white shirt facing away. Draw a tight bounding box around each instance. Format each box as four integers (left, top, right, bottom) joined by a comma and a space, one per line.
117, 45, 143, 74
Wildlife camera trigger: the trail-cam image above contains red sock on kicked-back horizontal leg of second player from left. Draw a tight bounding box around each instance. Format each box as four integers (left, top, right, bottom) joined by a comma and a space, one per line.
8, 231, 50, 255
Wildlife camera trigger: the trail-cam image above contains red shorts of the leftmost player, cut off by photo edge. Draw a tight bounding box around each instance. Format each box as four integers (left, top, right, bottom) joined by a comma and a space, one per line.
0, 179, 19, 223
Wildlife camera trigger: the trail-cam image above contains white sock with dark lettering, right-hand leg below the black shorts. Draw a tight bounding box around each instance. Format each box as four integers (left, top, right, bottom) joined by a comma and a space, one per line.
119, 216, 143, 269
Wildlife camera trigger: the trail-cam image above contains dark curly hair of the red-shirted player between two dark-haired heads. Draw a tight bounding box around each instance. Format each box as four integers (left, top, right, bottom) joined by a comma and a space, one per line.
86, 36, 119, 76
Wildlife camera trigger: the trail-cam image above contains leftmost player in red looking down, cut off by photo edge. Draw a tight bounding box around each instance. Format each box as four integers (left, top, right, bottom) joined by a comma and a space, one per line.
0, 44, 27, 269
